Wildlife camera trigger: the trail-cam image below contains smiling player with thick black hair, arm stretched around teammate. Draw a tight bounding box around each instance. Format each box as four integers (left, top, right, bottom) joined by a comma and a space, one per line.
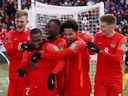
42, 20, 91, 96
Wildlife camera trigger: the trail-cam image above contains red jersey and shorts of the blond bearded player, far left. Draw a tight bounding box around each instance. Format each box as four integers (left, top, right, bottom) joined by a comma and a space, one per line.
5, 31, 28, 96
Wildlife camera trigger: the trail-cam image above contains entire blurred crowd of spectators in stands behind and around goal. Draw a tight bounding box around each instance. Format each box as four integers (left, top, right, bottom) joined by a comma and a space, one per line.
0, 0, 128, 31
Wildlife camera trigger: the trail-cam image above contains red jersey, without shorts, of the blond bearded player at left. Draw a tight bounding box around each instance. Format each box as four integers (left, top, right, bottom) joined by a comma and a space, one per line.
5, 31, 28, 73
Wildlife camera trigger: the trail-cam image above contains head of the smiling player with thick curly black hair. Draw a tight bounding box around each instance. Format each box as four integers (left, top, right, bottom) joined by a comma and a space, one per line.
61, 20, 78, 44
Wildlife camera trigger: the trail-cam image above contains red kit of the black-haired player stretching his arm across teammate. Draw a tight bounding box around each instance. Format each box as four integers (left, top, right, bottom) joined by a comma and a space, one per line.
44, 39, 91, 96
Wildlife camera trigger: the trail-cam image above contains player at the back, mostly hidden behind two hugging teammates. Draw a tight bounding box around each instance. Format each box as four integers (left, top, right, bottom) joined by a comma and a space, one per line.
47, 19, 66, 96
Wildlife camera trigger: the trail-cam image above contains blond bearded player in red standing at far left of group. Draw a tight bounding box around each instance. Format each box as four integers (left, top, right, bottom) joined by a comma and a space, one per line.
5, 10, 29, 96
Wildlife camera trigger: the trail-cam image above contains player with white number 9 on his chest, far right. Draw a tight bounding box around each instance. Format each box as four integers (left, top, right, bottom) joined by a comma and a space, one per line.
87, 14, 126, 96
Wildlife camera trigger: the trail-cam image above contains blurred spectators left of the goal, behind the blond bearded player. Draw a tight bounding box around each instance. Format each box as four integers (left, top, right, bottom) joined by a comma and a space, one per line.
0, 0, 31, 30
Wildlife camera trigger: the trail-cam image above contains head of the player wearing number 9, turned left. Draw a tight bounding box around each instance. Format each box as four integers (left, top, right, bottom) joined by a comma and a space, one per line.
100, 14, 116, 35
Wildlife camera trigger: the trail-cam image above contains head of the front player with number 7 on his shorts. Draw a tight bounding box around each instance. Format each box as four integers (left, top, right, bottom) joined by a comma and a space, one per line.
30, 28, 43, 48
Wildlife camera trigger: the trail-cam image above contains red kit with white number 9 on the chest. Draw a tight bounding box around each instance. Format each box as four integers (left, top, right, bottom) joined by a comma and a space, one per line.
94, 33, 125, 96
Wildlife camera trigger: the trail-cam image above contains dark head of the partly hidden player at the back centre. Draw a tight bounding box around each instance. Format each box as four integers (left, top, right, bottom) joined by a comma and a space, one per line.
47, 19, 61, 40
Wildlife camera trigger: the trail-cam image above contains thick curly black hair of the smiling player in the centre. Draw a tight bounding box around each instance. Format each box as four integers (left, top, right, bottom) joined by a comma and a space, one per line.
60, 19, 78, 33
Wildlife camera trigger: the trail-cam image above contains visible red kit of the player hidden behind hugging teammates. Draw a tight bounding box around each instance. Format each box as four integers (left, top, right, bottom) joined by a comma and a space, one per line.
50, 38, 66, 96
